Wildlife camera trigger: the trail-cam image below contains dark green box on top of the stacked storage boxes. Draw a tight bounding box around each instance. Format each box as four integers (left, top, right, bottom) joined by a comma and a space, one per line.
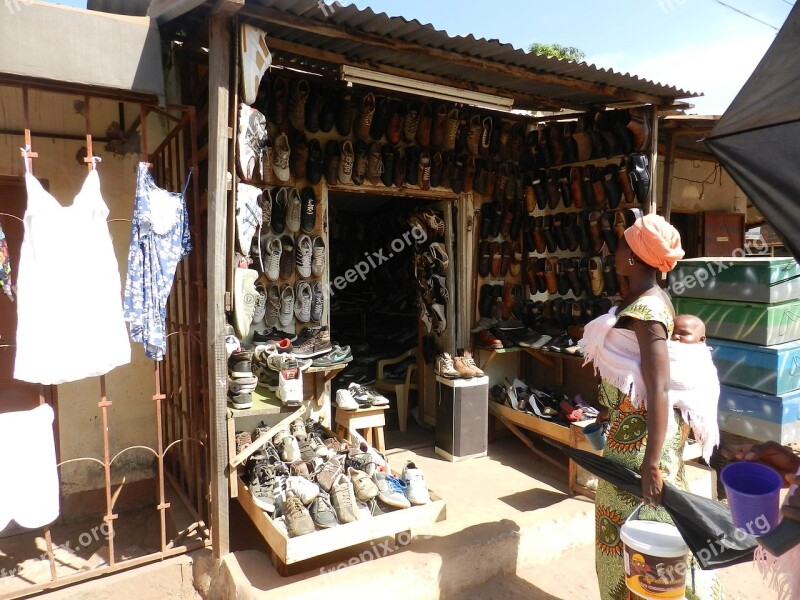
669, 256, 800, 303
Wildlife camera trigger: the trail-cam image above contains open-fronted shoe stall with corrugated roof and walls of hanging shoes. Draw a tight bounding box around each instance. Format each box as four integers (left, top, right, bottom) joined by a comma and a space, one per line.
130, 0, 720, 574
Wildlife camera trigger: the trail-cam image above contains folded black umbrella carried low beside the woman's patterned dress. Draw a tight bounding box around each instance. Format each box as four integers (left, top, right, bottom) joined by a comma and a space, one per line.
563, 448, 757, 570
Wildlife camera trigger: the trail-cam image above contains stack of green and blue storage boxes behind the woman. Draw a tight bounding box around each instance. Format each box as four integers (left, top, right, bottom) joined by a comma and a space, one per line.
668, 257, 800, 444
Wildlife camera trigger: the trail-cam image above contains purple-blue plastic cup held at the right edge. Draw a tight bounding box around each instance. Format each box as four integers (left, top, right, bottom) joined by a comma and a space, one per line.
720, 461, 783, 536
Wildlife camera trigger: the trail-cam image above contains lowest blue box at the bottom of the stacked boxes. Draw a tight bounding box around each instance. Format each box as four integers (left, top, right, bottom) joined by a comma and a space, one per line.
718, 385, 800, 444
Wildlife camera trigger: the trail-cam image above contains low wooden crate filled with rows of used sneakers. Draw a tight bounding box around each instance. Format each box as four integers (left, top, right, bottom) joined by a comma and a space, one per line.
233, 413, 445, 576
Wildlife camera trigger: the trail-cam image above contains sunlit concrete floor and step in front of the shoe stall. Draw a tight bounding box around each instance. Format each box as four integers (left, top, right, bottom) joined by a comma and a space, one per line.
221, 432, 776, 600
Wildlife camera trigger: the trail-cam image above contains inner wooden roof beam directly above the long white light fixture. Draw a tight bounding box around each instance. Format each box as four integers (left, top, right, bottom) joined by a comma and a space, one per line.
269, 37, 585, 110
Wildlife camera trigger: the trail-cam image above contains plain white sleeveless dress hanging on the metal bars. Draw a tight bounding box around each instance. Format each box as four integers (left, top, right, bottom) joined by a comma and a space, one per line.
14, 170, 131, 385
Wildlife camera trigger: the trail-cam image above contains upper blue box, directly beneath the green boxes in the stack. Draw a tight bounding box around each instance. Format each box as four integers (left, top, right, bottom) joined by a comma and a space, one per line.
706, 338, 800, 396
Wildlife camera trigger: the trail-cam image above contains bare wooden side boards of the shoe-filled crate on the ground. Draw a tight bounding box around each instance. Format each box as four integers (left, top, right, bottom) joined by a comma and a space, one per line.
236, 477, 446, 577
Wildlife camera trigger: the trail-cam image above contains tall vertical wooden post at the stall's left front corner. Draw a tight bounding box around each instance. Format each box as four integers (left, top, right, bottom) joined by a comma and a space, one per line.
206, 15, 231, 558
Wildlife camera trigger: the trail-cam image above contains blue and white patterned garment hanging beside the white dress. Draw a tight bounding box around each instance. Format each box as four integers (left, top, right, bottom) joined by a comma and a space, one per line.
124, 162, 192, 360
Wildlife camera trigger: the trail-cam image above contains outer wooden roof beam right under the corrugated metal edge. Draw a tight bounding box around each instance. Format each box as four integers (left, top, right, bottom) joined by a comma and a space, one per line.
240, 5, 672, 104
